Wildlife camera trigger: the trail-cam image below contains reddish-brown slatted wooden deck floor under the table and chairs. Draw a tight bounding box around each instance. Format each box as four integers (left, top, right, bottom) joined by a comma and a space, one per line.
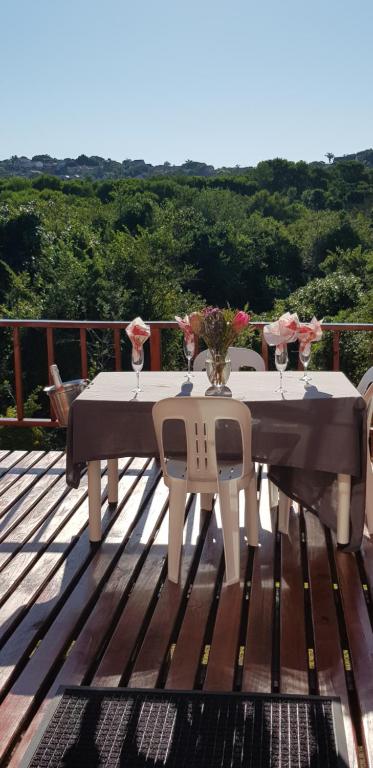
0, 451, 373, 768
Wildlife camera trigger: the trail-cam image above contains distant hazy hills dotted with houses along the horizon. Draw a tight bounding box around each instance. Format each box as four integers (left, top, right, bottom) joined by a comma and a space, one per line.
0, 149, 373, 181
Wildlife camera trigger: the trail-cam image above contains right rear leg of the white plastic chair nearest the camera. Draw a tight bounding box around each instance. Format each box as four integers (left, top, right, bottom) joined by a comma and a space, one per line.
219, 481, 240, 584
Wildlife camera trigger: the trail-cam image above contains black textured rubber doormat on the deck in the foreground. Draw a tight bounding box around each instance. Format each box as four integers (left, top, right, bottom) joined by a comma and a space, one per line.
22, 687, 348, 768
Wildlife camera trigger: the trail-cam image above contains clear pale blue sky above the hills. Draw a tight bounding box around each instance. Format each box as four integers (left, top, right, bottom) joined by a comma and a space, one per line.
0, 0, 373, 167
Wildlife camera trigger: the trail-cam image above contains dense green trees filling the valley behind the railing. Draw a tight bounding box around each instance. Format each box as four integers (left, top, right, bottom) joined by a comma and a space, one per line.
0, 159, 373, 442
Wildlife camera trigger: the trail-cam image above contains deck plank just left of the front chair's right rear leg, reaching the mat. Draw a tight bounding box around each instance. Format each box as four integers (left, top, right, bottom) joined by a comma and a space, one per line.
165, 512, 223, 690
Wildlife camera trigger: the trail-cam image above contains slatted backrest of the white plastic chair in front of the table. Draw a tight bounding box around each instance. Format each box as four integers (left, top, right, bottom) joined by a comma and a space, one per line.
153, 397, 251, 482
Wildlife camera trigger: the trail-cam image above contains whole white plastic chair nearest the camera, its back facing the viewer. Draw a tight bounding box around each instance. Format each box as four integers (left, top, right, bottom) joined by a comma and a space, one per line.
153, 397, 259, 584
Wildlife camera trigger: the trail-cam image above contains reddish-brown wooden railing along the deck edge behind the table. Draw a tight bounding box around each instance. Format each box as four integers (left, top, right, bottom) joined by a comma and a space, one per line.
0, 319, 373, 427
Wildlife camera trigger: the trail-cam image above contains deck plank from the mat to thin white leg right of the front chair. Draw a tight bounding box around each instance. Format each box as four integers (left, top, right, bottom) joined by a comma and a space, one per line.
280, 511, 309, 695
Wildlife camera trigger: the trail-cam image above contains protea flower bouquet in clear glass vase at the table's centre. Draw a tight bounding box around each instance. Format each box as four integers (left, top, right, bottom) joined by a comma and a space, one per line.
189, 307, 250, 395
